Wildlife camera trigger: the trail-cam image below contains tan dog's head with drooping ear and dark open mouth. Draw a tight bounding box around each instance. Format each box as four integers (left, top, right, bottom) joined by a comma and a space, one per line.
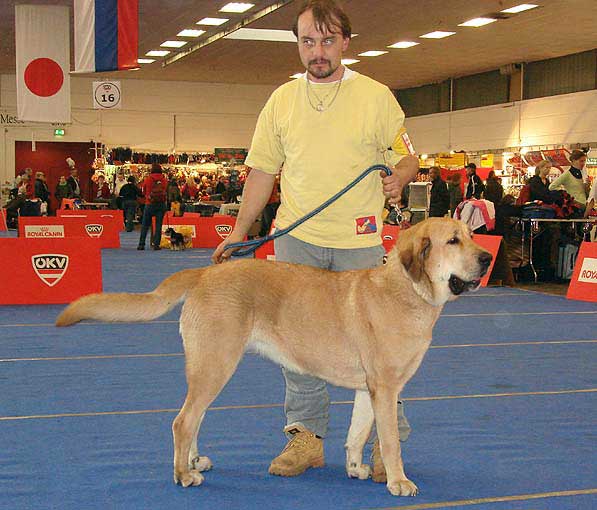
395, 218, 492, 305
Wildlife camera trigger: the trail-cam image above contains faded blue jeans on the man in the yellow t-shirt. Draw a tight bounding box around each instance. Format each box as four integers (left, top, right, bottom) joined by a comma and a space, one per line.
274, 235, 410, 441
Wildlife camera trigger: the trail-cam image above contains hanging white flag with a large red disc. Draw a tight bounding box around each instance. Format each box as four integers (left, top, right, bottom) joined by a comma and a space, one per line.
15, 5, 71, 123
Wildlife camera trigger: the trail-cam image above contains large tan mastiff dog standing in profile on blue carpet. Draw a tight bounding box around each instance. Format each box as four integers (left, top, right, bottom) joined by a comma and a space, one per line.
56, 218, 491, 496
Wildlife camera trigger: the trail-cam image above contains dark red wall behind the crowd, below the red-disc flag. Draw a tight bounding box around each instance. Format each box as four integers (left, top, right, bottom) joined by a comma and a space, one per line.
15, 141, 95, 211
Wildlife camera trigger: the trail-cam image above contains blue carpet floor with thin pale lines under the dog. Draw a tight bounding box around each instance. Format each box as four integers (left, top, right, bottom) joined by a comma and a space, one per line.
0, 233, 597, 510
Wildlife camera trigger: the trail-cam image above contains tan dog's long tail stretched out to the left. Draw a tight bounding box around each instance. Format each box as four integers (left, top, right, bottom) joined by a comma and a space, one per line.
56, 269, 201, 326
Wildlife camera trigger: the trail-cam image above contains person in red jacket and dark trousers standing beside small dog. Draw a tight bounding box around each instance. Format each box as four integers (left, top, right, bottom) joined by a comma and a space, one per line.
137, 163, 168, 250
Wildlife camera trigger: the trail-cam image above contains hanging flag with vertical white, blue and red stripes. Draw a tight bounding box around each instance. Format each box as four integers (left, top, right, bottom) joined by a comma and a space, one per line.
74, 0, 139, 73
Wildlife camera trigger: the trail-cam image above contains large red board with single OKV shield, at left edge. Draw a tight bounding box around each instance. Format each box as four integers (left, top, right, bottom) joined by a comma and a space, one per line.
0, 237, 102, 305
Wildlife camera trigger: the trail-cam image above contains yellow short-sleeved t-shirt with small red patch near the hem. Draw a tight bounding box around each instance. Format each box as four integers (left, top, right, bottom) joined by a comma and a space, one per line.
245, 71, 406, 248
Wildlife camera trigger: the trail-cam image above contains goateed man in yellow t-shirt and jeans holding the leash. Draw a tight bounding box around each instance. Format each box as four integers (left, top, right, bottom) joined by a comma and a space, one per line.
212, 0, 418, 476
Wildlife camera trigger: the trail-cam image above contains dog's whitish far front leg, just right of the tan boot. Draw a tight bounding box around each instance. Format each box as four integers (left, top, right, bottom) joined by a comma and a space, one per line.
345, 390, 374, 480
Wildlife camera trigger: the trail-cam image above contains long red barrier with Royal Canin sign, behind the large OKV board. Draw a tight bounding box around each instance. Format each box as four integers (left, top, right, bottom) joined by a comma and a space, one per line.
19, 216, 120, 248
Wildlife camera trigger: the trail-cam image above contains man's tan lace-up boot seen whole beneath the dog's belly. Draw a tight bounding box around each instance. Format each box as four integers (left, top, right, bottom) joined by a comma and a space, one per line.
269, 425, 324, 476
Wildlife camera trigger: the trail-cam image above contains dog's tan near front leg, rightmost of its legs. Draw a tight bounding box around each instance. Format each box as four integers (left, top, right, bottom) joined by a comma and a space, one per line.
370, 385, 419, 496
